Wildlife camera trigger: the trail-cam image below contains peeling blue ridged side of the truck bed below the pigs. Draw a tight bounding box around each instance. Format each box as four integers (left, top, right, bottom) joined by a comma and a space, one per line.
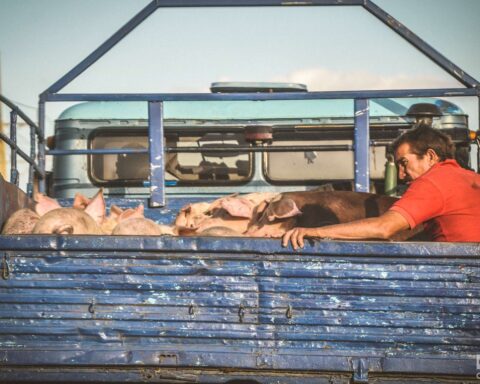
0, 176, 480, 383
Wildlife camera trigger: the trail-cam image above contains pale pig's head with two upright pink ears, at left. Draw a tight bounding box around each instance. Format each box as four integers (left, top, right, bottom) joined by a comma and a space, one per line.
32, 190, 105, 235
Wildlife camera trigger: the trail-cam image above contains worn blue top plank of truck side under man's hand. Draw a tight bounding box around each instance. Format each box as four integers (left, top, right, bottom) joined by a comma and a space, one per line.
0, 235, 480, 260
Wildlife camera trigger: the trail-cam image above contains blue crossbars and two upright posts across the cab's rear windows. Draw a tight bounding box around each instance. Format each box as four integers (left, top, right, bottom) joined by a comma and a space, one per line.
43, 89, 480, 207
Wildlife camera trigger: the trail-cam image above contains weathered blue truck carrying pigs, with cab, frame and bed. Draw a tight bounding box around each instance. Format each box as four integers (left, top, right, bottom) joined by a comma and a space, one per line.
0, 0, 480, 384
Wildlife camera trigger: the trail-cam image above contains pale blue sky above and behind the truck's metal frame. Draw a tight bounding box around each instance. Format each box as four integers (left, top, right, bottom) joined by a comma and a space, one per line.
0, 0, 480, 134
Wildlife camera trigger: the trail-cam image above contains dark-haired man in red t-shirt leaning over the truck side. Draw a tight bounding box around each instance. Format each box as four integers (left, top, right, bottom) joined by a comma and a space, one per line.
282, 126, 480, 249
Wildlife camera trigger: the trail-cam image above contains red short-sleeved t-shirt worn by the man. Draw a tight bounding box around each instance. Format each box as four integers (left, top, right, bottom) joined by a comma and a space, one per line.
390, 160, 480, 242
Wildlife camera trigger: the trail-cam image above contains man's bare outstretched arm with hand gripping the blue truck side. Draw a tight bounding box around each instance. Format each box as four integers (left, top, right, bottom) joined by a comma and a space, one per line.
282, 210, 410, 249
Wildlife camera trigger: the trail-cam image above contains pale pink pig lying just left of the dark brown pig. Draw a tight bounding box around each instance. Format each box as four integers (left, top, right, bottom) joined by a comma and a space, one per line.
175, 192, 278, 236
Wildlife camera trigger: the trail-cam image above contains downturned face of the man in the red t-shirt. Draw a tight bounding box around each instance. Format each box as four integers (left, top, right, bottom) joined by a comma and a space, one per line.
395, 143, 435, 183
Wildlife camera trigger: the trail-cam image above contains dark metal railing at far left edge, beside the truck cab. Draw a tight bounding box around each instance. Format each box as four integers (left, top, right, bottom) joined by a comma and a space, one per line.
0, 95, 45, 196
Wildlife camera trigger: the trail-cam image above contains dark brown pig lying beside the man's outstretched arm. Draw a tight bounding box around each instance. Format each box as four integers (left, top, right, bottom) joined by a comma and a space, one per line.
245, 191, 421, 240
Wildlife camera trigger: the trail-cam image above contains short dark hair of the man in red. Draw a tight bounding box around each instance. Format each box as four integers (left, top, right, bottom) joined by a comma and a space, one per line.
392, 124, 455, 161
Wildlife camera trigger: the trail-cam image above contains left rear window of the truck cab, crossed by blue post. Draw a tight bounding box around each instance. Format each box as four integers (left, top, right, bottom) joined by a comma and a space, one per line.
89, 129, 253, 186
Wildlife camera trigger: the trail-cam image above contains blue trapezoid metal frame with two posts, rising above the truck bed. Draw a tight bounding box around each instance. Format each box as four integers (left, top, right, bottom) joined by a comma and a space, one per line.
38, 0, 480, 206
